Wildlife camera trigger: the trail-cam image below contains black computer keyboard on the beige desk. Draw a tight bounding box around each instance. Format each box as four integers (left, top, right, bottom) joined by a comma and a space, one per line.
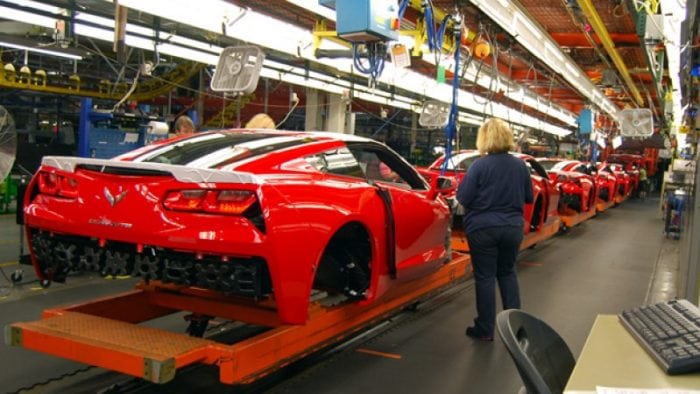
618, 300, 700, 375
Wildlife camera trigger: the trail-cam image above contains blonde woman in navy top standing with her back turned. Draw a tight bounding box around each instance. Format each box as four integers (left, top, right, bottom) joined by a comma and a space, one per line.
457, 118, 533, 341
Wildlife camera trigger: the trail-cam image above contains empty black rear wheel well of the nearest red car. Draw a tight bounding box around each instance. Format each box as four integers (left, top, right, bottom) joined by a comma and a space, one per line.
313, 222, 372, 298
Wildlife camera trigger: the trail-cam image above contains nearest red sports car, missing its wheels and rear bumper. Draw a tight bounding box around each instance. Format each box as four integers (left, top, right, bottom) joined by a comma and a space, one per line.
25, 130, 450, 324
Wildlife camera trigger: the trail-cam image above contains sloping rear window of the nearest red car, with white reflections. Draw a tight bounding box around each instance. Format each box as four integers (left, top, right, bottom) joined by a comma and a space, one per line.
134, 133, 313, 168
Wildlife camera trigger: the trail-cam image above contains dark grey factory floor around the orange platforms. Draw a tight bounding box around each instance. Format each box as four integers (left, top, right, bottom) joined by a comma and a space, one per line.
0, 197, 678, 394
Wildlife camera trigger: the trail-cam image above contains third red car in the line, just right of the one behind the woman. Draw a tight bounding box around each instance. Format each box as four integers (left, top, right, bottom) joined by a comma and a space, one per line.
537, 158, 597, 213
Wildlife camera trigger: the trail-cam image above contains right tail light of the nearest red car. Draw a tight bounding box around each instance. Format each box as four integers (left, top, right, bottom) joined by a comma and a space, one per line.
163, 190, 256, 215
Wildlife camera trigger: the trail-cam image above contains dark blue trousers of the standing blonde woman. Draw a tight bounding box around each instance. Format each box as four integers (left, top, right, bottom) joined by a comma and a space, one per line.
467, 226, 523, 336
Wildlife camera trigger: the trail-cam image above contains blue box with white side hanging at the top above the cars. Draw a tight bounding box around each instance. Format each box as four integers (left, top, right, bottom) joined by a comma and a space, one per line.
319, 0, 399, 42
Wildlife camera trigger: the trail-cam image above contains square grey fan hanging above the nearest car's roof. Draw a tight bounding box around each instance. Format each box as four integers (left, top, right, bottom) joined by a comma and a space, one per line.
211, 46, 265, 94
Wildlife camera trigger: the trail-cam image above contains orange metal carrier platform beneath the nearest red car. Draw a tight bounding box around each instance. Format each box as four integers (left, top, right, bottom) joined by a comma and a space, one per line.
5, 254, 471, 384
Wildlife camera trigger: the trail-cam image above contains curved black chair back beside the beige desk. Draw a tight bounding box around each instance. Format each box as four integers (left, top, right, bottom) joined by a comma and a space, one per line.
496, 309, 576, 394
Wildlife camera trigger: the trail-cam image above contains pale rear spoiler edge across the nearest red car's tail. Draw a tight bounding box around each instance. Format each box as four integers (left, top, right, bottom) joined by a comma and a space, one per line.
41, 156, 262, 184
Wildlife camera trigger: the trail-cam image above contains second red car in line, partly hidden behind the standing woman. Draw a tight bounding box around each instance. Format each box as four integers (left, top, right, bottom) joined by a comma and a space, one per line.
420, 150, 559, 234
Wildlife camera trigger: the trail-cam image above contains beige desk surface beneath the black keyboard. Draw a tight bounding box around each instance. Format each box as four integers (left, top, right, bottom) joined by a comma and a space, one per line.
564, 315, 700, 394
